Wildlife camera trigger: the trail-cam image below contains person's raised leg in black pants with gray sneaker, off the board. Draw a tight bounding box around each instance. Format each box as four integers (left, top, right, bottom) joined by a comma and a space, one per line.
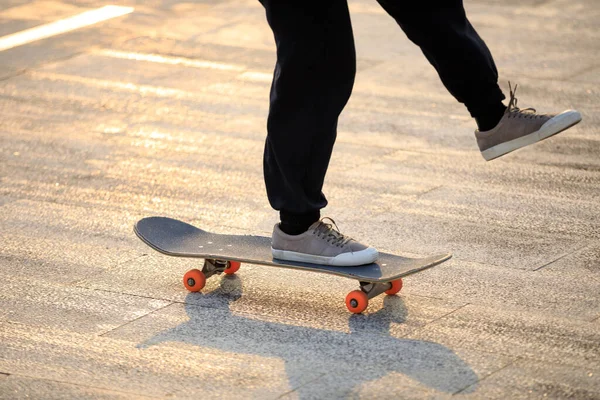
378, 0, 581, 161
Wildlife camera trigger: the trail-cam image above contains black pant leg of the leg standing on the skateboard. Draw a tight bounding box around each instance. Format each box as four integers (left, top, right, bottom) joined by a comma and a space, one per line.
261, 0, 356, 214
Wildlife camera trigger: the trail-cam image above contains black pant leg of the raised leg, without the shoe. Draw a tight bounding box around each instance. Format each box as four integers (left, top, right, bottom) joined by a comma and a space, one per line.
377, 0, 504, 117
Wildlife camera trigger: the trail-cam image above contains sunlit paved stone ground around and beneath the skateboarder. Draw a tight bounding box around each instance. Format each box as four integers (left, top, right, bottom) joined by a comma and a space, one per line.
0, 0, 600, 399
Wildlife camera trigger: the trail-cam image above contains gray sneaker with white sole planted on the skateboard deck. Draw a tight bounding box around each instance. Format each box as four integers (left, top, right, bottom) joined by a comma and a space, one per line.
271, 218, 379, 267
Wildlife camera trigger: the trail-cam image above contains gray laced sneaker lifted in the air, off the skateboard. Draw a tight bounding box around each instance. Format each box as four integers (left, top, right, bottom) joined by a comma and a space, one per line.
475, 83, 581, 161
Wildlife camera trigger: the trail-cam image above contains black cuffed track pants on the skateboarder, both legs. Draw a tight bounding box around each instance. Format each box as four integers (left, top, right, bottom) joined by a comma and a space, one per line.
261, 0, 504, 215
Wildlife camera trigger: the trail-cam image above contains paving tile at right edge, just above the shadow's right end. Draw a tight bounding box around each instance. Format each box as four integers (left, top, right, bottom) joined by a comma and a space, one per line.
407, 305, 600, 369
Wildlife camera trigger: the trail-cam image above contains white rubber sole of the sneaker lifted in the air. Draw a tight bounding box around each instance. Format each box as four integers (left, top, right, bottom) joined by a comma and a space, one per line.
481, 110, 581, 161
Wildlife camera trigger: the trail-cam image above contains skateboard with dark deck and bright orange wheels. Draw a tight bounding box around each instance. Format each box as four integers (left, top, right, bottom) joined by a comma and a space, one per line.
134, 217, 452, 314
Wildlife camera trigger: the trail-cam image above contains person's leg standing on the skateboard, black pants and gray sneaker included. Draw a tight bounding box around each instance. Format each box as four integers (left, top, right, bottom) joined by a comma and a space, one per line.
261, 0, 378, 266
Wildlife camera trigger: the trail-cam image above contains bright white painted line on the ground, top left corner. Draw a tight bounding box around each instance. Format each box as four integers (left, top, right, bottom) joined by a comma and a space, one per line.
0, 6, 133, 51
